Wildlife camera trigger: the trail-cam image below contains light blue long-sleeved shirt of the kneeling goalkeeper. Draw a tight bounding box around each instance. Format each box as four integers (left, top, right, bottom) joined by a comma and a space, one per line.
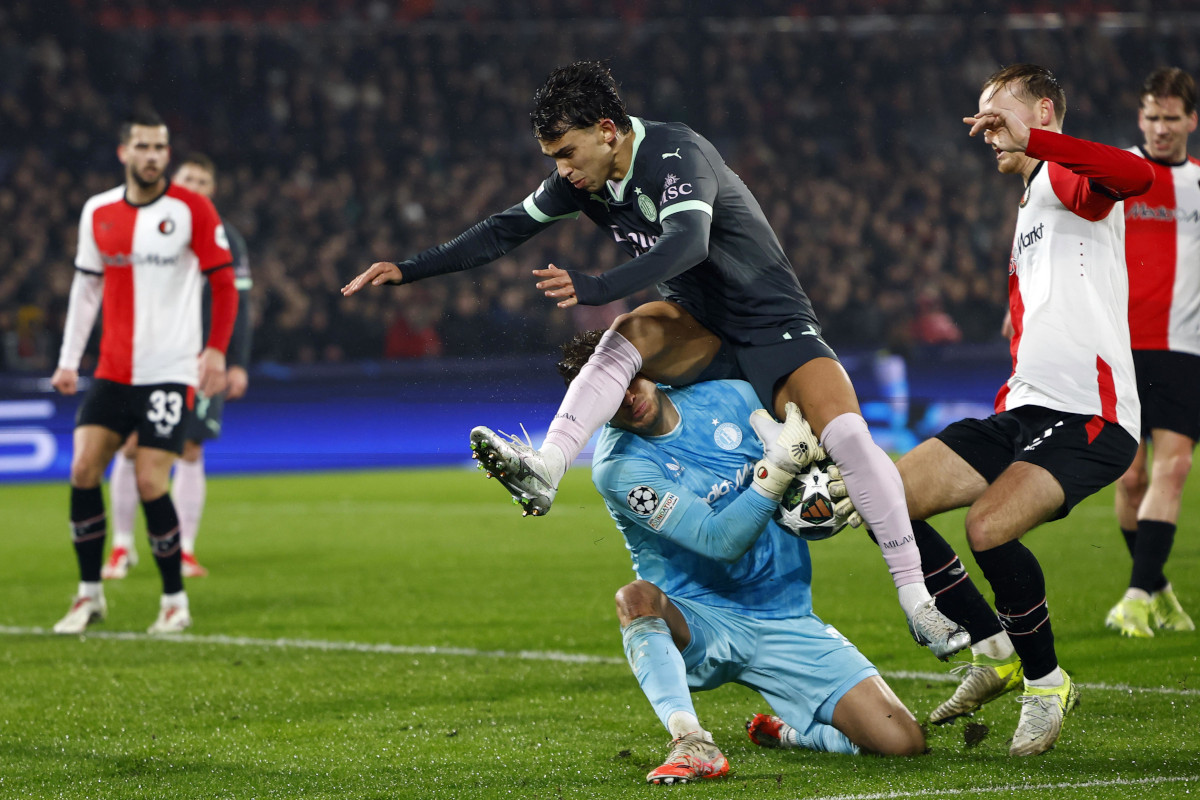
592, 380, 812, 619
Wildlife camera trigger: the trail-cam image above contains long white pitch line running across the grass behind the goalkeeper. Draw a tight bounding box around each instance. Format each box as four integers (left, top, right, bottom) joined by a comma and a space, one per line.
0, 625, 1200, 695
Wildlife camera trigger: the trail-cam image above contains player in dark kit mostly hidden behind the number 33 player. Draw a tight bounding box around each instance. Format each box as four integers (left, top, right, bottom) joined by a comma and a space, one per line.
101, 154, 253, 581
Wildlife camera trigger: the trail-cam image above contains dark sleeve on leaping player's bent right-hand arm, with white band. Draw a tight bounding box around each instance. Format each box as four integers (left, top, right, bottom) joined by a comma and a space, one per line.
569, 140, 719, 306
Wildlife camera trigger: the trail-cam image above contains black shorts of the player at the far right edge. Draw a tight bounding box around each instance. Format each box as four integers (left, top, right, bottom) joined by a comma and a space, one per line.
1133, 350, 1200, 441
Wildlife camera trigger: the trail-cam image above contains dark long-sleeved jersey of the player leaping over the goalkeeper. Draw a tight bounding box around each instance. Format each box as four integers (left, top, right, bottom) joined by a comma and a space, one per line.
400, 118, 820, 345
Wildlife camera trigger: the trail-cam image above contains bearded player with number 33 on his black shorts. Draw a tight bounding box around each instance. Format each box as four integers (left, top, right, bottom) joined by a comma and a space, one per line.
50, 113, 238, 633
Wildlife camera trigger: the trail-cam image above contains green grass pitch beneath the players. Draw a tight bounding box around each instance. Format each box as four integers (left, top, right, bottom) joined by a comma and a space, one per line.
0, 469, 1200, 800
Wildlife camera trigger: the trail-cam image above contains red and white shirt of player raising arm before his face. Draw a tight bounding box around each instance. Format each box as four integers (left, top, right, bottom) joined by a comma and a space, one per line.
996, 130, 1153, 439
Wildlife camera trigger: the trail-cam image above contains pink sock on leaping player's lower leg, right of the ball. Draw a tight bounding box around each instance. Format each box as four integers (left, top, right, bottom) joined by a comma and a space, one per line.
821, 414, 924, 589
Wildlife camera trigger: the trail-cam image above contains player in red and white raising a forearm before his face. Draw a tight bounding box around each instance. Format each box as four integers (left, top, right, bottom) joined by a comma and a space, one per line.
868, 64, 1153, 756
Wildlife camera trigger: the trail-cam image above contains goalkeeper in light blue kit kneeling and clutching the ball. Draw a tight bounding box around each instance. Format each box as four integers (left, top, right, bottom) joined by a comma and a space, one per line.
558, 331, 925, 783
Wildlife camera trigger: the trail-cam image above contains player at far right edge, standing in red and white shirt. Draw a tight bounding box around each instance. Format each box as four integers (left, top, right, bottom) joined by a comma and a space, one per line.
1105, 67, 1200, 637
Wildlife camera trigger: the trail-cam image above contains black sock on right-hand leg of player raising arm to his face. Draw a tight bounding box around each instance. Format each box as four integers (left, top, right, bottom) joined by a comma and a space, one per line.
972, 540, 1058, 680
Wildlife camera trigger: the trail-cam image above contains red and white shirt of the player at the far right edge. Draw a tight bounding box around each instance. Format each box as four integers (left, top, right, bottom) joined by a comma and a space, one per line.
1124, 148, 1200, 355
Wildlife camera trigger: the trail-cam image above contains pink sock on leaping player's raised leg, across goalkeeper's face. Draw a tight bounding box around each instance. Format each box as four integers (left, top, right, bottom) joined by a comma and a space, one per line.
541, 331, 642, 483
